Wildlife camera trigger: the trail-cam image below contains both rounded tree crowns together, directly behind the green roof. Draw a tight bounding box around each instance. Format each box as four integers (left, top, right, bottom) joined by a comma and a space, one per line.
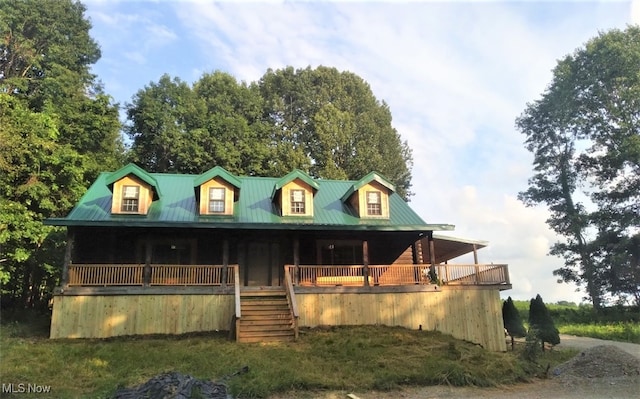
127, 67, 412, 197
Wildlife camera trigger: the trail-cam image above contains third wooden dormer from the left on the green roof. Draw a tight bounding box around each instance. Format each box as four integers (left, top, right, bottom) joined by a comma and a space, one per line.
271, 169, 320, 217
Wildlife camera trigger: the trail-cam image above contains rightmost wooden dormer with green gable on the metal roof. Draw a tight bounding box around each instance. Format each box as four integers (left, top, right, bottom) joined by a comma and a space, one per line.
341, 172, 395, 219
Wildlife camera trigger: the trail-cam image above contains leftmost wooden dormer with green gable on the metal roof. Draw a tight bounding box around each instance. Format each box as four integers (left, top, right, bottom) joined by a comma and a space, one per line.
105, 164, 160, 215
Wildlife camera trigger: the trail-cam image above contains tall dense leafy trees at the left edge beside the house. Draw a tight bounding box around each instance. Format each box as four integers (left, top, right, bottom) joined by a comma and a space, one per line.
0, 0, 122, 305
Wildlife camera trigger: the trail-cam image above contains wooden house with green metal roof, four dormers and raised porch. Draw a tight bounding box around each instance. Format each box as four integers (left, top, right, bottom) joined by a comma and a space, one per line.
48, 164, 511, 351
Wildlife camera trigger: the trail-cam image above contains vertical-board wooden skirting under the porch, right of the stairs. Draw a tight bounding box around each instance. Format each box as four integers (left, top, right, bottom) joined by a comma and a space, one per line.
296, 288, 506, 351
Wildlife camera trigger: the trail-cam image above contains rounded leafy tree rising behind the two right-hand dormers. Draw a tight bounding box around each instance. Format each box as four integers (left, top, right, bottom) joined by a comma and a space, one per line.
258, 66, 412, 198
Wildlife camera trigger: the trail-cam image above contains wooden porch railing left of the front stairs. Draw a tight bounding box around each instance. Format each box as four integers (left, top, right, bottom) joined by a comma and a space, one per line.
67, 264, 237, 287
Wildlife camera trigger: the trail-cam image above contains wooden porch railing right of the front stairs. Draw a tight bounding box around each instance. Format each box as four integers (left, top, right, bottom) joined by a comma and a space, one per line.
285, 264, 509, 286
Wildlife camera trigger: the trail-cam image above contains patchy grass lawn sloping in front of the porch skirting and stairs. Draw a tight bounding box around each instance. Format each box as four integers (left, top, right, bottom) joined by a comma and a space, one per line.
0, 321, 575, 398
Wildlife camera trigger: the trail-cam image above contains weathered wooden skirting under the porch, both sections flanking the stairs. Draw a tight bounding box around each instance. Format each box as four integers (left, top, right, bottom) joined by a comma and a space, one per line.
50, 285, 506, 351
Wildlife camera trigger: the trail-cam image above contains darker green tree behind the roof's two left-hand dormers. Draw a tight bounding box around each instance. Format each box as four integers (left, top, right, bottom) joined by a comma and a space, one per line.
127, 72, 271, 175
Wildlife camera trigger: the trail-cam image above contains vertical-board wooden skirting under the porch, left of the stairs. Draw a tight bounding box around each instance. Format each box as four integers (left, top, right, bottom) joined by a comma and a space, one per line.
50, 294, 234, 338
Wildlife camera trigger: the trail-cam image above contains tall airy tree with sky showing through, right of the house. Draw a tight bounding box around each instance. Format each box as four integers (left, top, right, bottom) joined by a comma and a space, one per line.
516, 27, 640, 309
